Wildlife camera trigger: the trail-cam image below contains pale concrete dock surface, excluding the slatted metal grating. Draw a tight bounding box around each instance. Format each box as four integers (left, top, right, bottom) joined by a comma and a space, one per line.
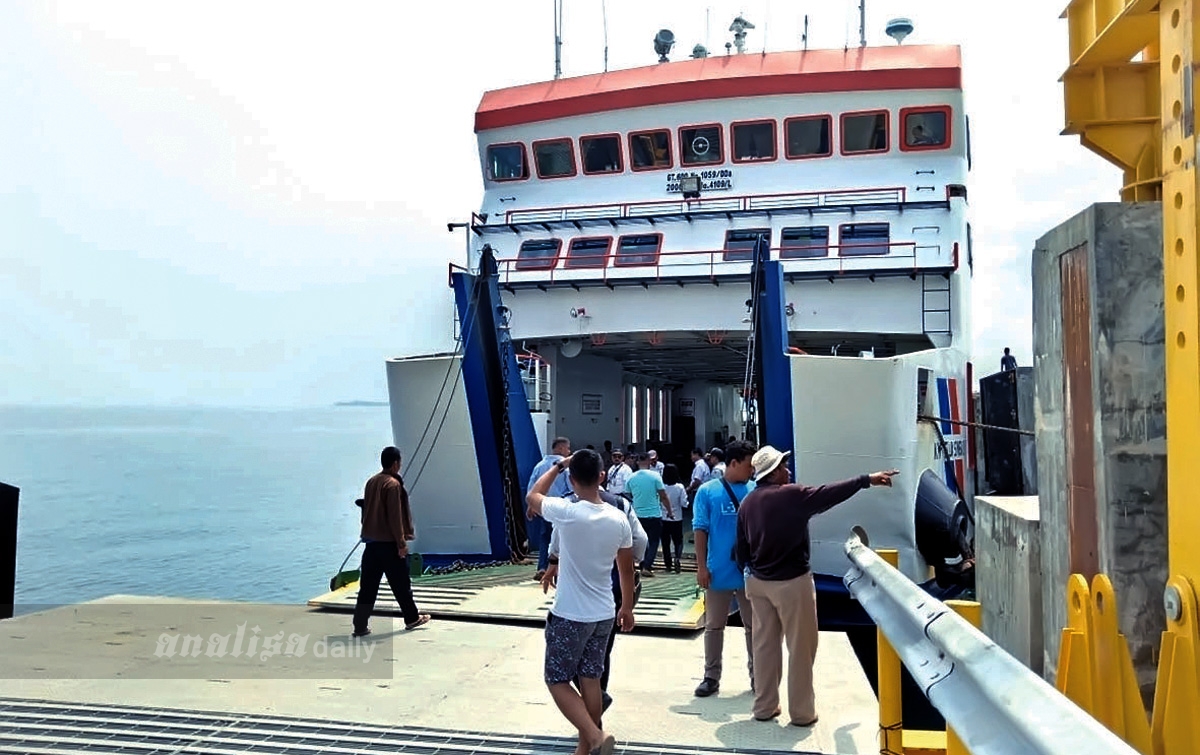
0, 595, 878, 754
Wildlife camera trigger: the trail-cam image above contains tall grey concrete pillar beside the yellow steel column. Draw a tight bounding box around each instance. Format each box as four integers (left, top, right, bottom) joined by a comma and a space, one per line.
1033, 203, 1166, 701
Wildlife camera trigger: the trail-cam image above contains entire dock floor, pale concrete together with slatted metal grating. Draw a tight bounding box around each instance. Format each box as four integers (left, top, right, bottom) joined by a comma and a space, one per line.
0, 597, 878, 755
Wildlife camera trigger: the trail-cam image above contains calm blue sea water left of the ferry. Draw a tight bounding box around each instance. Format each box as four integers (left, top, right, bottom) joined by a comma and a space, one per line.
0, 407, 391, 611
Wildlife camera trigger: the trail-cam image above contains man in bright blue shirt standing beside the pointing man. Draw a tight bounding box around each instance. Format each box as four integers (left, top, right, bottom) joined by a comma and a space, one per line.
691, 441, 756, 697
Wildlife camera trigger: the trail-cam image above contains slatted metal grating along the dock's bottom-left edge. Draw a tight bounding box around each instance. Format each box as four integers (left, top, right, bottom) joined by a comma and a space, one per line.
0, 697, 816, 755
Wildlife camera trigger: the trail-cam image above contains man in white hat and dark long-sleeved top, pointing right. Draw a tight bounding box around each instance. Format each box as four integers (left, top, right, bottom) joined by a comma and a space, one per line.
737, 445, 900, 726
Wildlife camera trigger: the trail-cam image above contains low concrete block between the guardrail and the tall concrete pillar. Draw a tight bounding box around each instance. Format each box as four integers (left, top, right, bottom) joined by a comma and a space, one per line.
976, 496, 1045, 673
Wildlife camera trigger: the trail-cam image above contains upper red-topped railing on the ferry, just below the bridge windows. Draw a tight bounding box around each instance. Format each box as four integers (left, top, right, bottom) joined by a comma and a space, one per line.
504, 186, 908, 224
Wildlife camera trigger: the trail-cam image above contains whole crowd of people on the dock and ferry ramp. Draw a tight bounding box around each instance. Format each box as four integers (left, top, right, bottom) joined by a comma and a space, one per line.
354, 437, 898, 755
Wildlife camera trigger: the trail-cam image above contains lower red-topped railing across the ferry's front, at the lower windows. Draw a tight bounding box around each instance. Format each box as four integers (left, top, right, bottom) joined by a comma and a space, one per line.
497, 241, 958, 286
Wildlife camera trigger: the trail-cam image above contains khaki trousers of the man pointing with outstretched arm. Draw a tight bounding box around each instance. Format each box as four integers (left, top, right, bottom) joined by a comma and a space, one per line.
746, 571, 817, 724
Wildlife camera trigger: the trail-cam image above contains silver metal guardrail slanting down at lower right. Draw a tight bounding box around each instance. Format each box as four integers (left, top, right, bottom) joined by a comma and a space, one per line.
845, 537, 1138, 755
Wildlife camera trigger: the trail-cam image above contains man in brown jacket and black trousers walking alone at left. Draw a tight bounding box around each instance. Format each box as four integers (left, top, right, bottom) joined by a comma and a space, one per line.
354, 445, 430, 637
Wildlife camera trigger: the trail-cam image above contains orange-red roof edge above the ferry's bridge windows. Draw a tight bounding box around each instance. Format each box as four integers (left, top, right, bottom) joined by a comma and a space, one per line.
475, 44, 962, 132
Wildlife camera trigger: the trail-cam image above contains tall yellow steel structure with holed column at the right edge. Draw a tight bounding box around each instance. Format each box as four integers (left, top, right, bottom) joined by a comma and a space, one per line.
1060, 0, 1200, 755
